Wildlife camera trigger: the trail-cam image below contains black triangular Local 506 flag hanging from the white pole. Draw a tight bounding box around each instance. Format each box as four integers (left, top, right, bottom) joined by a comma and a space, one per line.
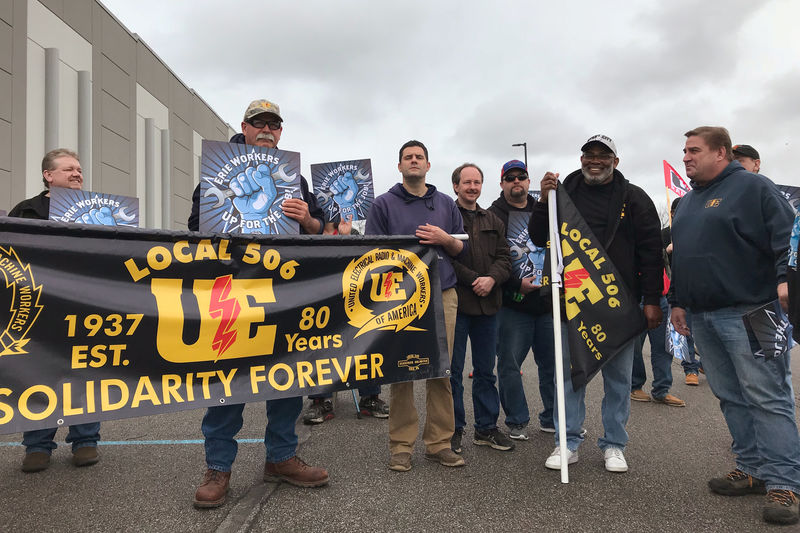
545, 188, 647, 388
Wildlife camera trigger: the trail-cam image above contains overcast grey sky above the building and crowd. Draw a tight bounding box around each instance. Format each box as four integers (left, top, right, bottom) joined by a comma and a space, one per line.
102, 0, 800, 210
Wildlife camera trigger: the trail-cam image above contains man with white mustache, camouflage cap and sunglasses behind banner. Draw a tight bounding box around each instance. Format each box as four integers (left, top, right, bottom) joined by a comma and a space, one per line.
188, 100, 328, 508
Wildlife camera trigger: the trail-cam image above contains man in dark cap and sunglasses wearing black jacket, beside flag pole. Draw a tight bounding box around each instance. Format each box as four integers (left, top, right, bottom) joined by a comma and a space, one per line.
489, 160, 555, 440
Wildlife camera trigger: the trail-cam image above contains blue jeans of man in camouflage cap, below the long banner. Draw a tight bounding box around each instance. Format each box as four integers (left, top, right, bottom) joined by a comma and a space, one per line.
201, 396, 303, 472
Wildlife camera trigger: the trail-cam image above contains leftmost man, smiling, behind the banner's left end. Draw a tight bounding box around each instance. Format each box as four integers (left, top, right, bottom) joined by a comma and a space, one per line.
8, 148, 100, 472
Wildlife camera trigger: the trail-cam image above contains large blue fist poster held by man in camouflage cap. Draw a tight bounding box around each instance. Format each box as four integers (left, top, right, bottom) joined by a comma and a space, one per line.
200, 140, 303, 235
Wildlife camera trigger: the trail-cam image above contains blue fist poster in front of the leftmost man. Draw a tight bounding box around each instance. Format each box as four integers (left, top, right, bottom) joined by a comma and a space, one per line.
50, 187, 139, 228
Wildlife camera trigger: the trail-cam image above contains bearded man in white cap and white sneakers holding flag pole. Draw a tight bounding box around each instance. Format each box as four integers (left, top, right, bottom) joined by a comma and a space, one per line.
529, 135, 664, 472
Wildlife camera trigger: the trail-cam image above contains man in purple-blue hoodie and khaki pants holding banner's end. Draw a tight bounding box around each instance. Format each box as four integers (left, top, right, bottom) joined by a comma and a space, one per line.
366, 141, 467, 472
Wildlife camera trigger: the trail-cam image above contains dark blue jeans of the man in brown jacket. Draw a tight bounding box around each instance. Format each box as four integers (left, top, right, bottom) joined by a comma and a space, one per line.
450, 313, 500, 431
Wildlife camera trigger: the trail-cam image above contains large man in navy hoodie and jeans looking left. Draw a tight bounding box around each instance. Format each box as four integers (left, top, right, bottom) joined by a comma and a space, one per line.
671, 126, 800, 524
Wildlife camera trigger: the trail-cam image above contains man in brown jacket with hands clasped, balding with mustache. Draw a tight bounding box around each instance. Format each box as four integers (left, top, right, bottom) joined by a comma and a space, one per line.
450, 163, 514, 453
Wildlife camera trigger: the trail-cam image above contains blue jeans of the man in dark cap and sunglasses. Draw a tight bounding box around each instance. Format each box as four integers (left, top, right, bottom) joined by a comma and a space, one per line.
497, 307, 556, 427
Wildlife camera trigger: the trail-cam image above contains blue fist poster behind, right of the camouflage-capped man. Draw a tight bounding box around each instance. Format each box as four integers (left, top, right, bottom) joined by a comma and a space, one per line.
311, 159, 375, 222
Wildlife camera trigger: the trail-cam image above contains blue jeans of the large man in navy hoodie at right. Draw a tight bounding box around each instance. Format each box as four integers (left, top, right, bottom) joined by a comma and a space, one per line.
691, 306, 800, 493
